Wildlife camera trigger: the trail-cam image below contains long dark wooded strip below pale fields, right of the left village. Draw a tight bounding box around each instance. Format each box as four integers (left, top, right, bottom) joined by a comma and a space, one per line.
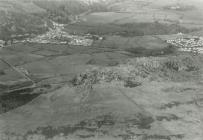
66, 22, 197, 37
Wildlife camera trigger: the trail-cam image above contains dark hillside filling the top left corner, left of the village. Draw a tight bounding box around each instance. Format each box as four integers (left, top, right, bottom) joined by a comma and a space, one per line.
0, 0, 48, 41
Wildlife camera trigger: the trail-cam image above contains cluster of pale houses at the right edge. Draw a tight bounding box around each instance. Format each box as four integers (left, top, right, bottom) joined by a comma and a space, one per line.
167, 35, 203, 54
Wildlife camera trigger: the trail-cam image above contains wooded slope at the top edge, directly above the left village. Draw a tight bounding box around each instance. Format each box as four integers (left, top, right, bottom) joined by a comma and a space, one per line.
34, 0, 108, 23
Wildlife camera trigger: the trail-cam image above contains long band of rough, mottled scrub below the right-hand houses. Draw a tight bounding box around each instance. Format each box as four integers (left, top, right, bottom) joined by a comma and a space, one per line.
72, 55, 201, 87
